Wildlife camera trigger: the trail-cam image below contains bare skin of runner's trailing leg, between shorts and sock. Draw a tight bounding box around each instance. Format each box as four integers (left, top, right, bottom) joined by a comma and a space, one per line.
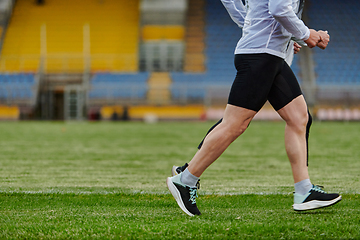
188, 104, 256, 177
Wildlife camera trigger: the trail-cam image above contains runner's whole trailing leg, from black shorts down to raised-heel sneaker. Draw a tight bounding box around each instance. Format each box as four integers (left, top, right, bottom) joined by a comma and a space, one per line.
166, 54, 282, 216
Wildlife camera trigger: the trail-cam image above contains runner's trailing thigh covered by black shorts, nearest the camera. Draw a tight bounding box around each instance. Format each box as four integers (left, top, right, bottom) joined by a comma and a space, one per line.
228, 54, 283, 112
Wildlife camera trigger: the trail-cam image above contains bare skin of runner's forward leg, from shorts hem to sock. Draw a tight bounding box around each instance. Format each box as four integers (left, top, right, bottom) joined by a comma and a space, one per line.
278, 95, 309, 183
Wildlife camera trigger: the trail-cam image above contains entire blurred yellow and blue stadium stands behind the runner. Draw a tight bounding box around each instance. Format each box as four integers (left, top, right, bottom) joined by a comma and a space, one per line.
0, 0, 360, 119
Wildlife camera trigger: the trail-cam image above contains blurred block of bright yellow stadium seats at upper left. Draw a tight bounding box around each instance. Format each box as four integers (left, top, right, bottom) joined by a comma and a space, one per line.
0, 0, 139, 73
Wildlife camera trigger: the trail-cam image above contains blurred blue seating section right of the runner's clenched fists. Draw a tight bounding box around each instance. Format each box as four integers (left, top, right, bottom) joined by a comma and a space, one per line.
307, 0, 360, 121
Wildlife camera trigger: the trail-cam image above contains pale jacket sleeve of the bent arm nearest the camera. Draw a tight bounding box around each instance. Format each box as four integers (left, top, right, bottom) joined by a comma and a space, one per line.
269, 0, 310, 40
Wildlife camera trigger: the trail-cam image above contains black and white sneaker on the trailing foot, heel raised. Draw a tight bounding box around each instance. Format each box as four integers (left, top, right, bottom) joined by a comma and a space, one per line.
166, 173, 201, 216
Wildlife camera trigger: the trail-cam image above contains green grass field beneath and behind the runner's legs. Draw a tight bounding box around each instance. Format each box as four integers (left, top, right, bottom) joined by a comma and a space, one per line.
0, 122, 360, 239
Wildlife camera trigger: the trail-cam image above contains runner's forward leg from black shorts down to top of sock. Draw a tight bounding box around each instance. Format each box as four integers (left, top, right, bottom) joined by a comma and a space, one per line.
268, 62, 310, 183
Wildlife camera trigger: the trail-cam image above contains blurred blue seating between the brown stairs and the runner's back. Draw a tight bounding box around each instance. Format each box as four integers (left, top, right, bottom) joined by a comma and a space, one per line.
171, 1, 241, 101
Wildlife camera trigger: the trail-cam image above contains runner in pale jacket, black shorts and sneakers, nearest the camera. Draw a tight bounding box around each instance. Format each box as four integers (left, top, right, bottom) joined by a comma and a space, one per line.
166, 0, 341, 216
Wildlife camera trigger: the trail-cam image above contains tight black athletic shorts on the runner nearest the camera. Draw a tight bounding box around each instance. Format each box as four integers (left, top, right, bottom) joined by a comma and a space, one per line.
228, 53, 302, 111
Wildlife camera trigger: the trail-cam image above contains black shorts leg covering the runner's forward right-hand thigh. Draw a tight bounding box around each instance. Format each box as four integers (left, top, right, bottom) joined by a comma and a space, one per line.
268, 62, 302, 111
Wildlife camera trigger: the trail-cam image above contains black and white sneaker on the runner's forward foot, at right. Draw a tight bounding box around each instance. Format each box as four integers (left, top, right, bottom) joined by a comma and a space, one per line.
293, 185, 341, 211
